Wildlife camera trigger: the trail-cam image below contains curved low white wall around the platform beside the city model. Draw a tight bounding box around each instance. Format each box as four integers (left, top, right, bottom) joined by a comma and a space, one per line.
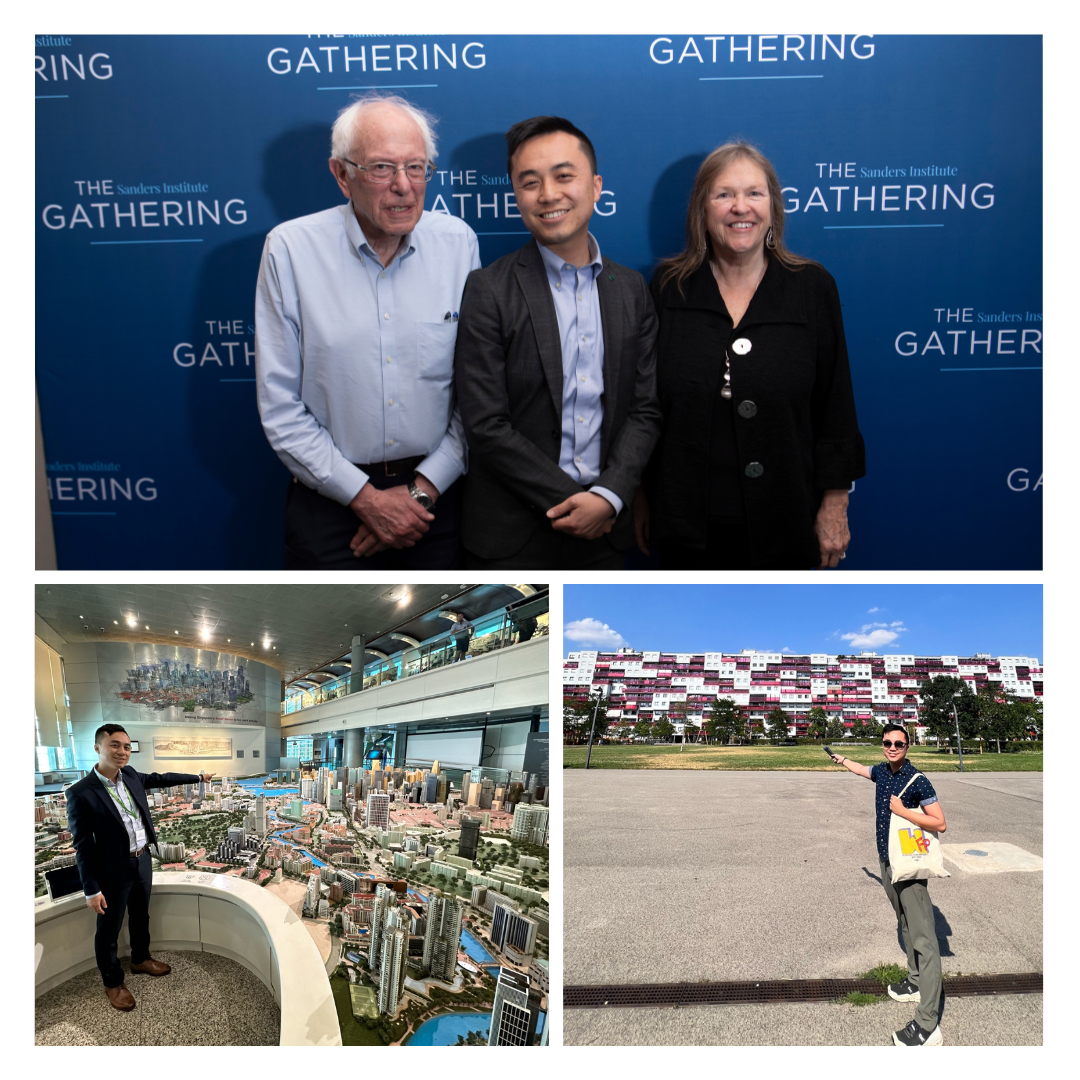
33, 872, 341, 1047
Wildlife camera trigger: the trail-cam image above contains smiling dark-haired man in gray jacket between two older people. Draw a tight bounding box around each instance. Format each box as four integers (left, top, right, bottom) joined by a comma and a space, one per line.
454, 117, 661, 570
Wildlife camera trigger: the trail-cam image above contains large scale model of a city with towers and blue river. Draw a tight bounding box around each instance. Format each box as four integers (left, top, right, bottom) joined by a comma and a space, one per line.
35, 761, 549, 1045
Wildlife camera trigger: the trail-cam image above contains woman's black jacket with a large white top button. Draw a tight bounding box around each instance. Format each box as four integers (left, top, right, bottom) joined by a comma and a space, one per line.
646, 258, 866, 569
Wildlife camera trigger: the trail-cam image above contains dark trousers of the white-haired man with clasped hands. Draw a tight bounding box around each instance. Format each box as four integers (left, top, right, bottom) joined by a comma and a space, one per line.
285, 473, 460, 570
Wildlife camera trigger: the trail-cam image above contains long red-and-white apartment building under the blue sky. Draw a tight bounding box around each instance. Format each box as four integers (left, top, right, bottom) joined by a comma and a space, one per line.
563, 649, 1043, 737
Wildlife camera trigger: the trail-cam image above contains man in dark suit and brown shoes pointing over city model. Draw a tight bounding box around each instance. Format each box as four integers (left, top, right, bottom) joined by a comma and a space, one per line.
67, 724, 211, 1012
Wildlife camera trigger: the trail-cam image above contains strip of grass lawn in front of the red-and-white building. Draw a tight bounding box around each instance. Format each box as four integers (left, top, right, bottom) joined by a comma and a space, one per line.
563, 739, 1042, 772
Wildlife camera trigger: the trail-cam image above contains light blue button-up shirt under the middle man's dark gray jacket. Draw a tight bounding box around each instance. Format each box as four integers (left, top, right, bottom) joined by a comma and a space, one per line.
537, 233, 622, 514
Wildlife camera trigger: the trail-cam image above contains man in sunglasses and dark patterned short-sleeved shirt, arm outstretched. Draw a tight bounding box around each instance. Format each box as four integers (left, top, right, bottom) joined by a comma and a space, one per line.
831, 724, 945, 1047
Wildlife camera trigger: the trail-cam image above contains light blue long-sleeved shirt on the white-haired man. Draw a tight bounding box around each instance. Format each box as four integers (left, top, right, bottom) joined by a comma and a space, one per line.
255, 203, 480, 505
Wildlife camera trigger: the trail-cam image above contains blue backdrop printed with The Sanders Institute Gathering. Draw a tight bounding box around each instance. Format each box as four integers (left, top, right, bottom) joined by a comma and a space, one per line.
35, 35, 1043, 569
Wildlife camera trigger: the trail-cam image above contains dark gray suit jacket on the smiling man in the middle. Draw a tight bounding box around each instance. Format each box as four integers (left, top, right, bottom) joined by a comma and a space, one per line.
454, 240, 661, 558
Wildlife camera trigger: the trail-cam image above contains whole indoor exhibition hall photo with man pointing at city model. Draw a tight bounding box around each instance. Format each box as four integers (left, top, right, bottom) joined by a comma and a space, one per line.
33, 584, 550, 1045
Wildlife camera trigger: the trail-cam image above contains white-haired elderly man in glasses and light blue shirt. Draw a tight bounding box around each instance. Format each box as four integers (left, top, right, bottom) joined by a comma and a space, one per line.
255, 95, 480, 570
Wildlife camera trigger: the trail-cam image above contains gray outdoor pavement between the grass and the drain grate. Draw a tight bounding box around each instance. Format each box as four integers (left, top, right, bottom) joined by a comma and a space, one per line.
563, 770, 1042, 989
